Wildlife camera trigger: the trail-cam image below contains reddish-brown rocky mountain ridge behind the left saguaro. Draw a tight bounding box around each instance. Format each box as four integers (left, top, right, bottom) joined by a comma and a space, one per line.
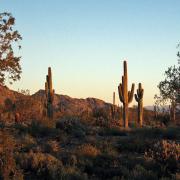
0, 85, 111, 120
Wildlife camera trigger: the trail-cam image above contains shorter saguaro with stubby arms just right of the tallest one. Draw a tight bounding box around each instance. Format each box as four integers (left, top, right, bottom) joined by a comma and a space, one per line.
135, 83, 144, 126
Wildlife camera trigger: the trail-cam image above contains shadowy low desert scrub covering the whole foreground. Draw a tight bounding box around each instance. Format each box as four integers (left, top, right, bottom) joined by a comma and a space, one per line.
0, 117, 180, 180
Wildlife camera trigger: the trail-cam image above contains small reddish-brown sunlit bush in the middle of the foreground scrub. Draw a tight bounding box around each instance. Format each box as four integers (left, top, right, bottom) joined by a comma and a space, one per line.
76, 144, 100, 157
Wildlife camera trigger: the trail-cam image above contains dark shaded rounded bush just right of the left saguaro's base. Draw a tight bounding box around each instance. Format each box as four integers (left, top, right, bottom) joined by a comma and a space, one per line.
56, 117, 89, 138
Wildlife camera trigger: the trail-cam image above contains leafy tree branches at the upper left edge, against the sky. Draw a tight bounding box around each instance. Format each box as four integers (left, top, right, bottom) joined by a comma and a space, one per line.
0, 13, 22, 84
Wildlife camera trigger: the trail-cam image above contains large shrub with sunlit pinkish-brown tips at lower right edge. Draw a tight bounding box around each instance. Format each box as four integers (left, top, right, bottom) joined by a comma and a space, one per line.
145, 140, 180, 173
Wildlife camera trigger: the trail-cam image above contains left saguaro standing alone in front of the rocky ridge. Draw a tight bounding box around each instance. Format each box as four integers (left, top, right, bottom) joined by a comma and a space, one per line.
45, 67, 54, 118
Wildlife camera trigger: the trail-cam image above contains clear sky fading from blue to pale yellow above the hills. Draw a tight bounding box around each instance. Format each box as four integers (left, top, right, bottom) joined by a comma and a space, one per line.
0, 0, 180, 105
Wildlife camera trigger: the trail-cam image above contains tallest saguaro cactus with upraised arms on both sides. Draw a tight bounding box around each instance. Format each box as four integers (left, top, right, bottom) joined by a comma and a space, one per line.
118, 61, 135, 128
